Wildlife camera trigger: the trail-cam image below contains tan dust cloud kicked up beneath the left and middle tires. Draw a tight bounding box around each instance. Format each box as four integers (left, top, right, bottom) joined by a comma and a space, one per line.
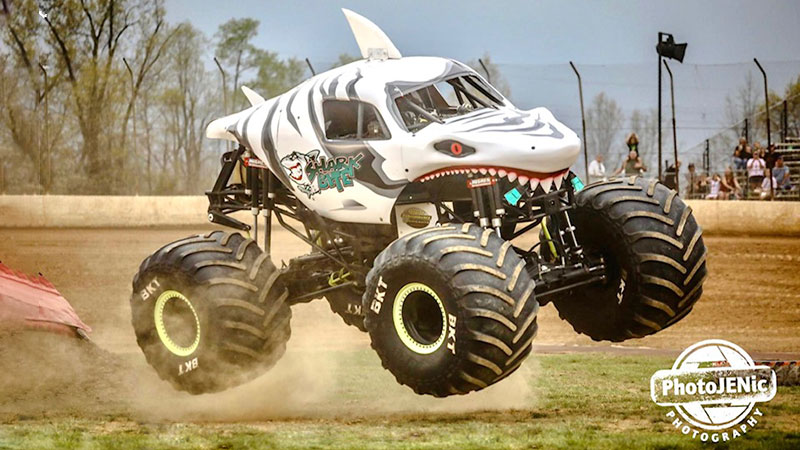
0, 302, 536, 422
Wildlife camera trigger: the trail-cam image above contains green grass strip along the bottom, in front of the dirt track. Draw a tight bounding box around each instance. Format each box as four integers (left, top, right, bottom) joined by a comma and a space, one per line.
0, 351, 800, 450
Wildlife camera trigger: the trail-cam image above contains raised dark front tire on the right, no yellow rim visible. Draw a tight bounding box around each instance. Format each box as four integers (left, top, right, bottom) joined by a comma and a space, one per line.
553, 177, 706, 342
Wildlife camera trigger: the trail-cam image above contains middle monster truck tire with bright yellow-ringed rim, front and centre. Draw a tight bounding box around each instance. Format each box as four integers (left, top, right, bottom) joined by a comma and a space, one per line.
364, 224, 539, 397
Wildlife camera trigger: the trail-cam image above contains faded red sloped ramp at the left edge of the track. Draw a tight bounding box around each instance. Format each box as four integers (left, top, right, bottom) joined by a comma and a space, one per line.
0, 263, 91, 335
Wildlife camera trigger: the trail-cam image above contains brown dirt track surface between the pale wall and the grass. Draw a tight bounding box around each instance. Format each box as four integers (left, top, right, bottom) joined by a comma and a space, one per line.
0, 229, 800, 420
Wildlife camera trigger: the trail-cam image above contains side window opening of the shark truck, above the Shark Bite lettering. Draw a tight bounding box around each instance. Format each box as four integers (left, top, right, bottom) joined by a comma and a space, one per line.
322, 100, 391, 141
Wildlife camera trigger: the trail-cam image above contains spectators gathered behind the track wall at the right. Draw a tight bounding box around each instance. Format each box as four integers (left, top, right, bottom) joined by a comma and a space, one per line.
588, 133, 792, 200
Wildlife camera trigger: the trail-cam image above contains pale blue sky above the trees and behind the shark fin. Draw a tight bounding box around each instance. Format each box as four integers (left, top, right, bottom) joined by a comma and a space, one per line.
167, 0, 800, 165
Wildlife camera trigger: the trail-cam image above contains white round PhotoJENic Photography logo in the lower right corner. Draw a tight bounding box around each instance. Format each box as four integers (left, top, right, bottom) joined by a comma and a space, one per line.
650, 339, 776, 442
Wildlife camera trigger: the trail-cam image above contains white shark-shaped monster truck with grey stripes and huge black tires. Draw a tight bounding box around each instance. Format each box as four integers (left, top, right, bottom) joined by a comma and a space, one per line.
131, 11, 706, 397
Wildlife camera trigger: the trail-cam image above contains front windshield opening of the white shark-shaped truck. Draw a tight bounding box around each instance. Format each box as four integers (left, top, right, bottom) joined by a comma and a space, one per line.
395, 75, 503, 132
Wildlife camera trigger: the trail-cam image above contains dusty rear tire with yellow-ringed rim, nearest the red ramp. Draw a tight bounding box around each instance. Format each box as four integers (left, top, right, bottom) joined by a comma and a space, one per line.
131, 231, 291, 394
